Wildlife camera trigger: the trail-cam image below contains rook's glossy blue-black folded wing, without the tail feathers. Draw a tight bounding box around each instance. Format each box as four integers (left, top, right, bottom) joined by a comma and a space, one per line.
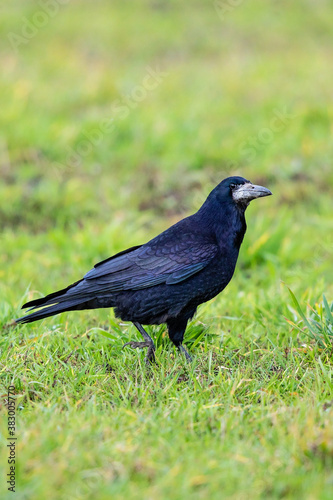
84, 233, 218, 292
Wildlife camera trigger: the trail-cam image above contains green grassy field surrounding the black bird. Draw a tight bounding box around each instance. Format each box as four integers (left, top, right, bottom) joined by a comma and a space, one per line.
0, 0, 333, 500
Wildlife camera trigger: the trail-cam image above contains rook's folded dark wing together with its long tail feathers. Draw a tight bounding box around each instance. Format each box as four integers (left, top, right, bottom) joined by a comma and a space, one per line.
23, 233, 218, 320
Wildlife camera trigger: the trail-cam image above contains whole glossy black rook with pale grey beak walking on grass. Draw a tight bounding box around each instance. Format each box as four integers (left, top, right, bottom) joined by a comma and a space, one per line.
16, 177, 272, 362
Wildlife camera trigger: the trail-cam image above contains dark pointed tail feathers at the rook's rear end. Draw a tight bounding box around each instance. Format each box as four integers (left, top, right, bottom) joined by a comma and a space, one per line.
15, 279, 96, 323
